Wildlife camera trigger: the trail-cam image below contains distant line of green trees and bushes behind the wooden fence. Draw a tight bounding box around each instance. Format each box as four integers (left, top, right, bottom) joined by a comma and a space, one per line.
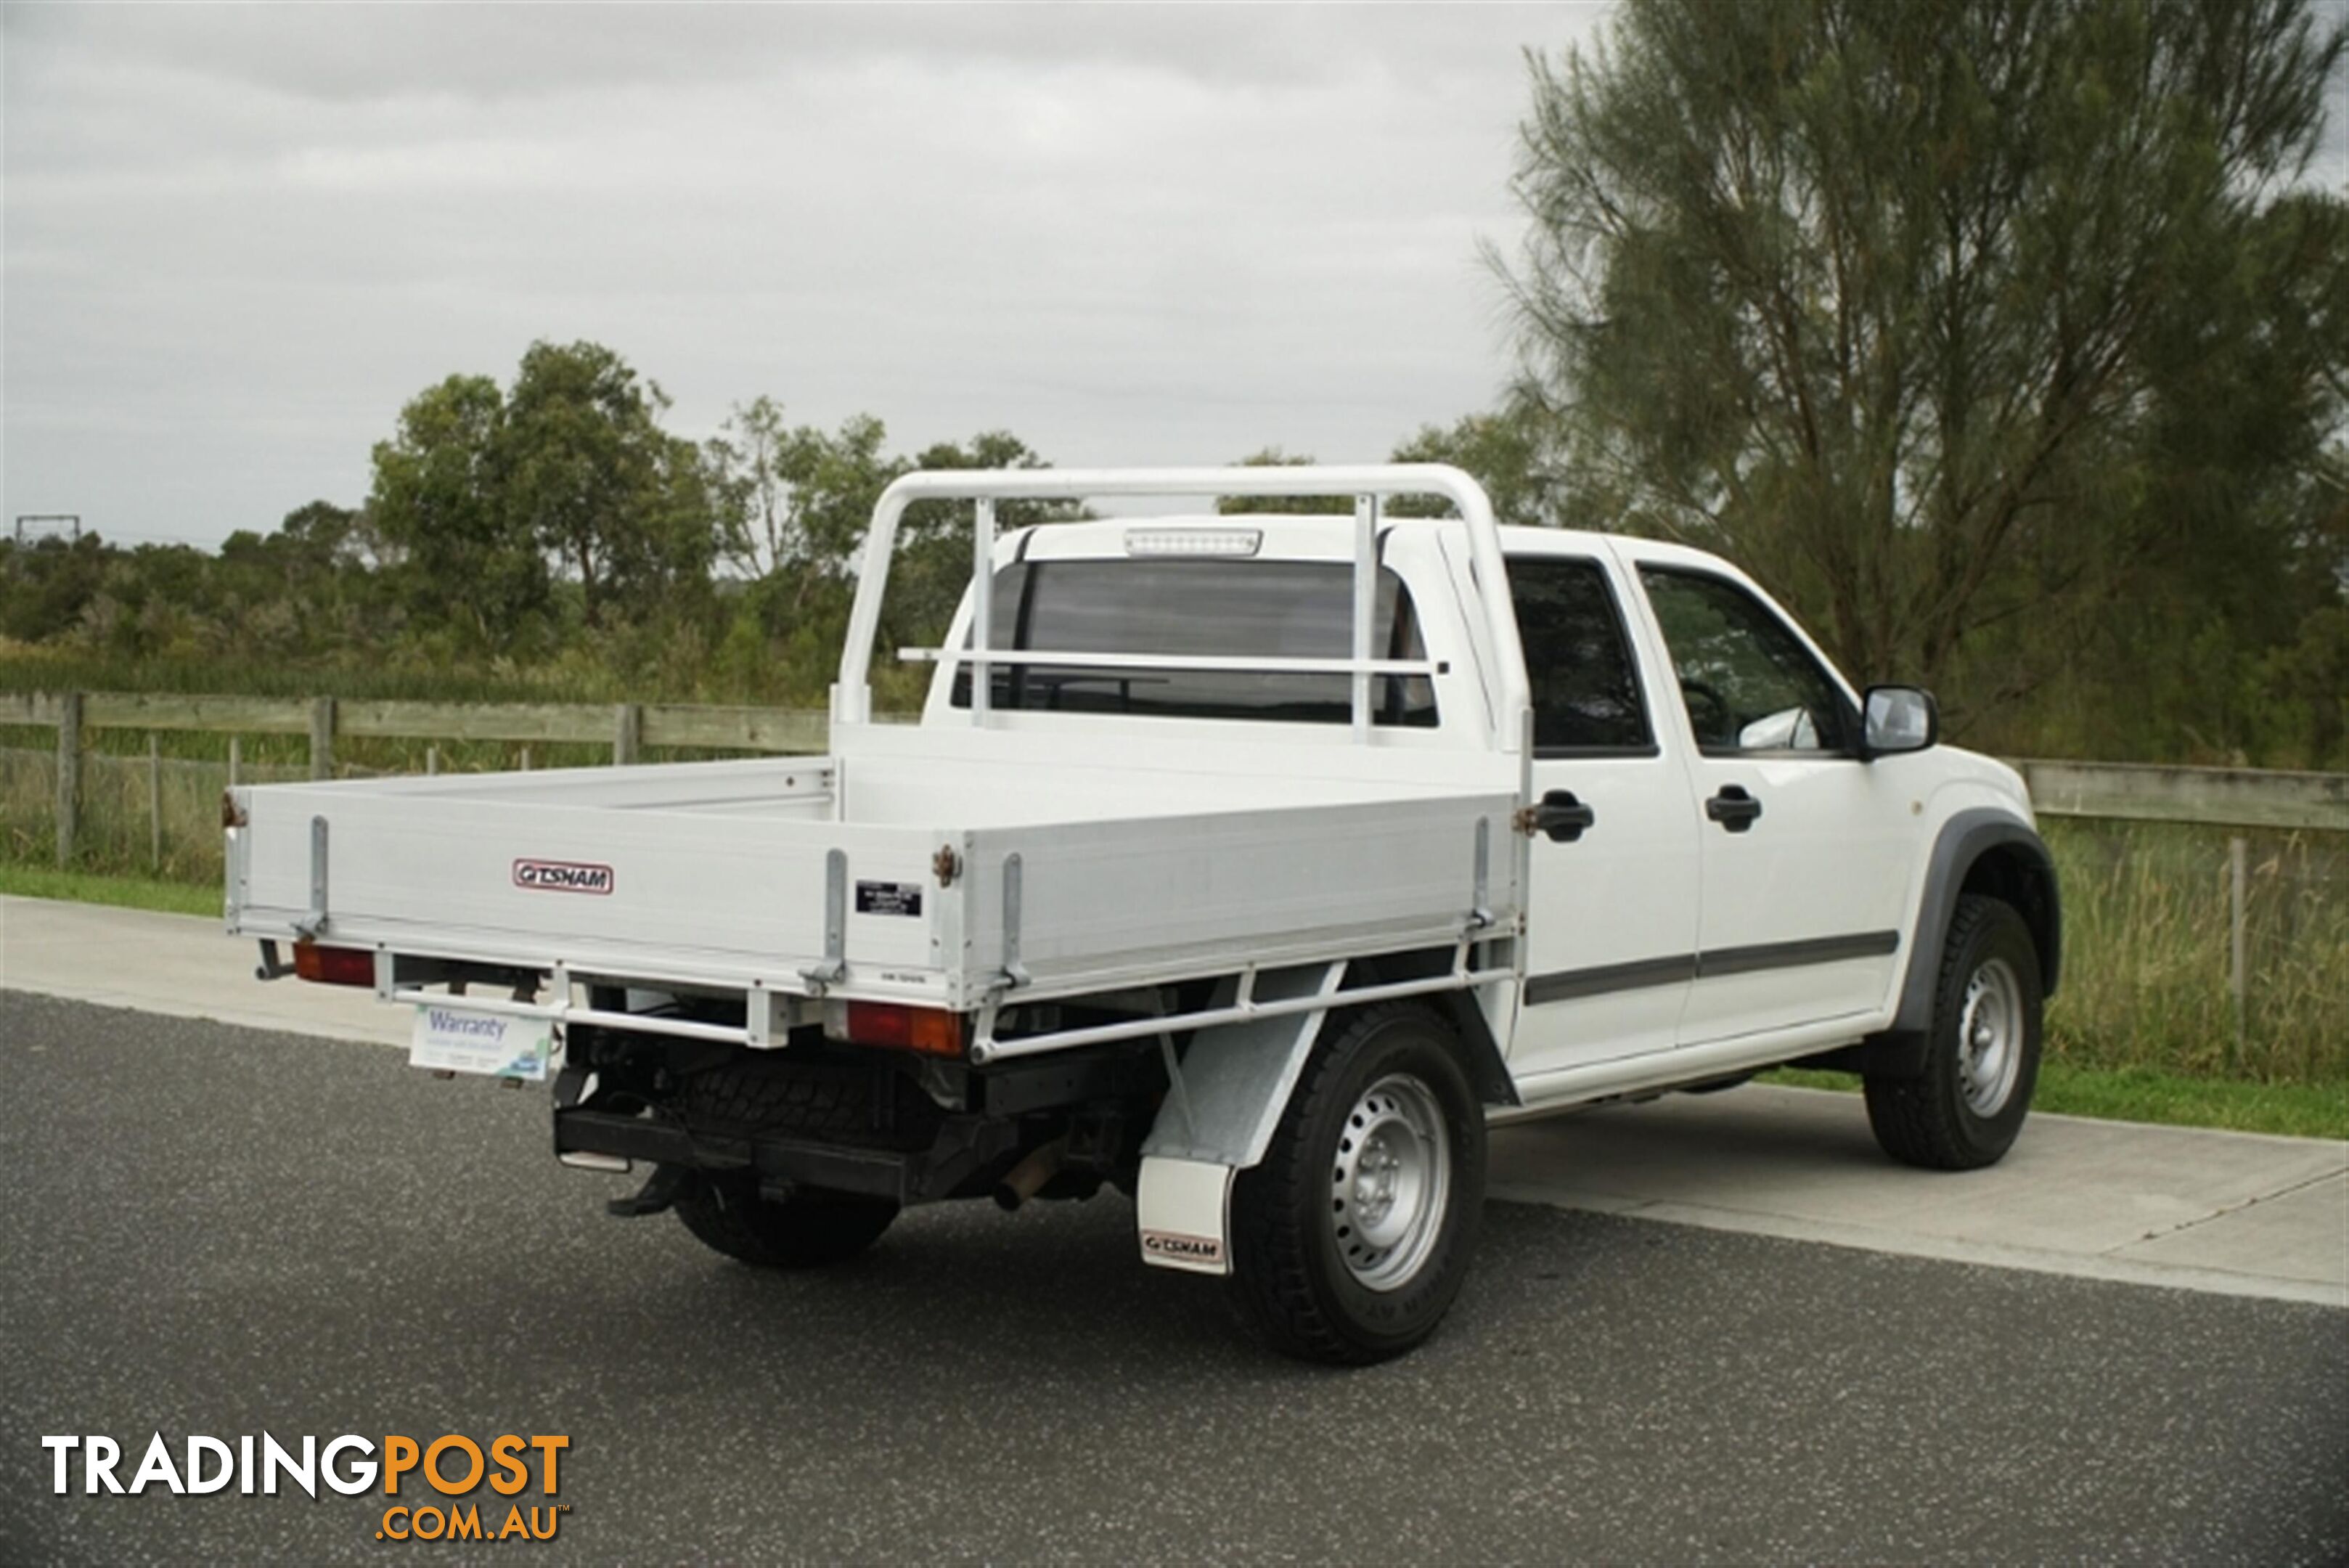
0, 343, 2349, 767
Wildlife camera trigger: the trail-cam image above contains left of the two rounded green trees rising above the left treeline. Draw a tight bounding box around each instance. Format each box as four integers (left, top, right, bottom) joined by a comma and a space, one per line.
367, 376, 547, 649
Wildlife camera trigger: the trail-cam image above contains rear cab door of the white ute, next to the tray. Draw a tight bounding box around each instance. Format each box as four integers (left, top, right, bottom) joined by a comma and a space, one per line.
1508, 539, 1699, 1101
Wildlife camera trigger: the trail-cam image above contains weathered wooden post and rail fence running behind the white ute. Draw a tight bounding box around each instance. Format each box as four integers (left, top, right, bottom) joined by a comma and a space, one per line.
0, 691, 2349, 1053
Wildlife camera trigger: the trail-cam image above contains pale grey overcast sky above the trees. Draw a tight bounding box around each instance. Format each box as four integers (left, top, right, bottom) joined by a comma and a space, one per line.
0, 4, 1604, 543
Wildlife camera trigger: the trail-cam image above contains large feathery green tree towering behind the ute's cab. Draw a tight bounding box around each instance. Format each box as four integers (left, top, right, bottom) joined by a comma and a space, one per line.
1506, 0, 2349, 679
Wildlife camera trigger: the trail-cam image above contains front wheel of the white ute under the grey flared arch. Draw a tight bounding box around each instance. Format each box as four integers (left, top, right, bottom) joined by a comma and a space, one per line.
1865, 894, 2041, 1171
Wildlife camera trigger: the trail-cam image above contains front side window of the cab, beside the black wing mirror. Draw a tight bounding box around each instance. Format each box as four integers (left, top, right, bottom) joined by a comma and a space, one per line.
1640, 566, 1851, 755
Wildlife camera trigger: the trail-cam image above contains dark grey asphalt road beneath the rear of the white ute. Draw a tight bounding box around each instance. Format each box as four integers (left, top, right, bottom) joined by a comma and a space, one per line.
0, 992, 2349, 1564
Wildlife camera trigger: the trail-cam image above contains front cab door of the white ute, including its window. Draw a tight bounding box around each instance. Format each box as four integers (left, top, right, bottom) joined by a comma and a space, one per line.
1637, 555, 1917, 1044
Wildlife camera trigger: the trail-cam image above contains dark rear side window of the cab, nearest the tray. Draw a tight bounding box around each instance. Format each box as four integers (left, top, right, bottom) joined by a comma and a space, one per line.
1508, 555, 1656, 757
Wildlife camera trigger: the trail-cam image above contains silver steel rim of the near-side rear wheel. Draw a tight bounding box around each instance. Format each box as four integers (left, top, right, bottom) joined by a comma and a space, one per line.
1330, 1072, 1452, 1291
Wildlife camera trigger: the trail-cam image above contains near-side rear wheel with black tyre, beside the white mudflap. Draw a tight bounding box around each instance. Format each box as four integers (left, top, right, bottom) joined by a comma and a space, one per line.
1231, 1006, 1484, 1365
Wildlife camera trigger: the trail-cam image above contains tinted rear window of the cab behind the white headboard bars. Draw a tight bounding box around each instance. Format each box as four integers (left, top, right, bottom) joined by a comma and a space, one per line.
954, 557, 1435, 727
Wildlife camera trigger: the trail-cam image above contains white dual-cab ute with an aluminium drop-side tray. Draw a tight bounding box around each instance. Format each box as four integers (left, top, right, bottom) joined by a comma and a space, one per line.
226, 465, 2060, 1361
